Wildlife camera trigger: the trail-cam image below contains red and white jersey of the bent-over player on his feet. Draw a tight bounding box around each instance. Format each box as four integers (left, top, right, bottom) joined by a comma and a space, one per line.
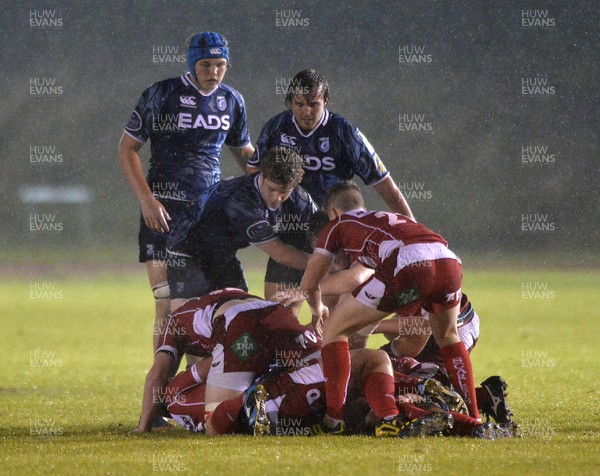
315, 209, 448, 269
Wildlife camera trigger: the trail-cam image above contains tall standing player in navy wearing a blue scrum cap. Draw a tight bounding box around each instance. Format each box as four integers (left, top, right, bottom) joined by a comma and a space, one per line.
118, 32, 254, 345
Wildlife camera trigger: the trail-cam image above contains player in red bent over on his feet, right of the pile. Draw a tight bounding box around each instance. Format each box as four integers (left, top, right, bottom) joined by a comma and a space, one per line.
292, 182, 479, 432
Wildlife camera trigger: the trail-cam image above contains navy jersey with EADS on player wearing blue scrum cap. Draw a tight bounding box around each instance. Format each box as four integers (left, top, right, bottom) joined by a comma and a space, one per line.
125, 73, 250, 201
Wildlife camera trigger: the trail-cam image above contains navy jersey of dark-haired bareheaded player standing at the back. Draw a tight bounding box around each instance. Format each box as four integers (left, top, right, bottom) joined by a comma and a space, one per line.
248, 109, 389, 205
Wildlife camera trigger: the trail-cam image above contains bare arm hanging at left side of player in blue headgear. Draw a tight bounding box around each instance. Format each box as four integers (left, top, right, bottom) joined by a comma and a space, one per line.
118, 133, 171, 233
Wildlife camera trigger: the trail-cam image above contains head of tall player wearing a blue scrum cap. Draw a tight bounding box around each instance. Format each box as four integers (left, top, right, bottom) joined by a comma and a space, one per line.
188, 31, 229, 92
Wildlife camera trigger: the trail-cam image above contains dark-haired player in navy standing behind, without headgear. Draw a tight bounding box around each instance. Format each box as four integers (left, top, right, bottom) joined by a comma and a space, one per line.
248, 69, 413, 299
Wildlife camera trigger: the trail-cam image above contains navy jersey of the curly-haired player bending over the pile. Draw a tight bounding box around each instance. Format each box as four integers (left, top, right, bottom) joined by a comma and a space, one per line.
167, 173, 317, 257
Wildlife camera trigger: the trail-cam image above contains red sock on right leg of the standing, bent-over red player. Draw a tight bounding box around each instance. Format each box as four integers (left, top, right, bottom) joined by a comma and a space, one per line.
440, 342, 480, 418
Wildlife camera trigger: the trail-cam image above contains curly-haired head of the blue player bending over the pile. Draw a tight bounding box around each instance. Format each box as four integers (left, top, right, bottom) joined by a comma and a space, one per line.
258, 146, 304, 209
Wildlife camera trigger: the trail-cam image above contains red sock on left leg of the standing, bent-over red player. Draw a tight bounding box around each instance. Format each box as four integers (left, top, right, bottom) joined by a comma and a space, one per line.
321, 341, 350, 420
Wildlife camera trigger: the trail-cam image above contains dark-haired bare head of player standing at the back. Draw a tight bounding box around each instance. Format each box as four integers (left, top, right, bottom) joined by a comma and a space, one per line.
285, 69, 329, 131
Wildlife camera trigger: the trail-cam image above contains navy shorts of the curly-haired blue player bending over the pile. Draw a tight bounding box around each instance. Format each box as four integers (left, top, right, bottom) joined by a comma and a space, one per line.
167, 255, 248, 299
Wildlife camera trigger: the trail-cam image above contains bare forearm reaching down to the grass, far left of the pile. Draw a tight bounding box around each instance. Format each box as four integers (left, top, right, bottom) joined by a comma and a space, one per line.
138, 352, 174, 432
